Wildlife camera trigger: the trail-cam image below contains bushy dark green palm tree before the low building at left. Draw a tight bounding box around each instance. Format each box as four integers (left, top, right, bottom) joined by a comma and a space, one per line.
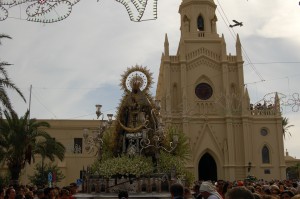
0, 110, 66, 183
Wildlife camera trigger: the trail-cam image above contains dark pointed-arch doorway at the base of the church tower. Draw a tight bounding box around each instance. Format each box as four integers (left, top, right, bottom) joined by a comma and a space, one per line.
198, 153, 218, 181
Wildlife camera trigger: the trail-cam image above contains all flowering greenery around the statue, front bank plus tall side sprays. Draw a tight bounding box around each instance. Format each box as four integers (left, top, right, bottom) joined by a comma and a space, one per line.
91, 127, 194, 183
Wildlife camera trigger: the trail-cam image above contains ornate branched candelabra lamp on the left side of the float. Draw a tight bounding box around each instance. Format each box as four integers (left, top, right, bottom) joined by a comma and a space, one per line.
83, 104, 113, 160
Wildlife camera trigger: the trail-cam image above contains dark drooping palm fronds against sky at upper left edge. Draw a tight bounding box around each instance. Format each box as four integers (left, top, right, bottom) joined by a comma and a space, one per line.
0, 34, 26, 115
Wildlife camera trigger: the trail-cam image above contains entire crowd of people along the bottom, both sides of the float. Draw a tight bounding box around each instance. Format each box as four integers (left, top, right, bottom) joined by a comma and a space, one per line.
0, 180, 300, 199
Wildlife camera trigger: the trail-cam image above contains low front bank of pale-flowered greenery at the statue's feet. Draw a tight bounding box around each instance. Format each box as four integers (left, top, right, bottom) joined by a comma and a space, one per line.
91, 155, 153, 178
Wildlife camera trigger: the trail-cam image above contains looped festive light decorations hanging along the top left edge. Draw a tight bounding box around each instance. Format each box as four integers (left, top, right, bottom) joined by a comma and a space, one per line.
0, 0, 158, 23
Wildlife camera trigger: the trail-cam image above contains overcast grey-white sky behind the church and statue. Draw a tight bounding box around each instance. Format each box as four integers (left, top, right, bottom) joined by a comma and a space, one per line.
0, 0, 300, 158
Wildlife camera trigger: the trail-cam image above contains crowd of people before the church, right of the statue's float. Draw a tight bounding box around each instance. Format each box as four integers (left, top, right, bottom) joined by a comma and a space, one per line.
170, 180, 300, 199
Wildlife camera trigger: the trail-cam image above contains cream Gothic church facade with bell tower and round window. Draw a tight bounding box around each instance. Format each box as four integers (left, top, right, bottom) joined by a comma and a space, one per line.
156, 0, 286, 180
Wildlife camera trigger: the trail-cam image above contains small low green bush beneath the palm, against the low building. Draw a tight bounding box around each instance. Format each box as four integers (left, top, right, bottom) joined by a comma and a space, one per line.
28, 163, 65, 186
